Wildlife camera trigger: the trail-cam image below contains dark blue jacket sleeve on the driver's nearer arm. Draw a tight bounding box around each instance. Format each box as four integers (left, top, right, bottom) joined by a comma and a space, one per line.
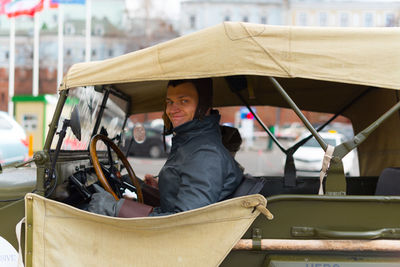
150, 145, 224, 216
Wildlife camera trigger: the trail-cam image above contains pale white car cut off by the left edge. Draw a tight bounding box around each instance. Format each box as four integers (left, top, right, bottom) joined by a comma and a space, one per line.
0, 111, 28, 165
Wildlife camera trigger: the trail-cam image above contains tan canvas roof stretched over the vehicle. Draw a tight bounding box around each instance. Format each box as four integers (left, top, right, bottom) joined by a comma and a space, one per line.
60, 22, 400, 116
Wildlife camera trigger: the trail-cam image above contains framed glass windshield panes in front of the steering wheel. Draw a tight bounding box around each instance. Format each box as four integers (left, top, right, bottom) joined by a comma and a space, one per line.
51, 86, 128, 150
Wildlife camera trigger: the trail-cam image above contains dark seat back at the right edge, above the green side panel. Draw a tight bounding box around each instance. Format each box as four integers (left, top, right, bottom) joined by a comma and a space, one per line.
375, 168, 400, 196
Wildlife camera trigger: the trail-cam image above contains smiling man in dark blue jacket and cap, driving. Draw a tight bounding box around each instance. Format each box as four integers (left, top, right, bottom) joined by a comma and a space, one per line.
145, 78, 243, 216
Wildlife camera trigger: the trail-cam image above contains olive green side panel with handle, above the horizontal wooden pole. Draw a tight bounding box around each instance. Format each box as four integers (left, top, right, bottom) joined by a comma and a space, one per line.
243, 195, 400, 239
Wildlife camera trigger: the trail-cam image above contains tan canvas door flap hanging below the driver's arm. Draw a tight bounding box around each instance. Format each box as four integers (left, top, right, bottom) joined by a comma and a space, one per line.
26, 194, 266, 266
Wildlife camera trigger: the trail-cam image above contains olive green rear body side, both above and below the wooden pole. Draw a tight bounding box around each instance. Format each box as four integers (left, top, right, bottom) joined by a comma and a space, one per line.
221, 195, 400, 267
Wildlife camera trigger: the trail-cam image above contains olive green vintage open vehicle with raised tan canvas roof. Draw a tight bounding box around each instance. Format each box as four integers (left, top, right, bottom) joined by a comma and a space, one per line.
0, 23, 400, 267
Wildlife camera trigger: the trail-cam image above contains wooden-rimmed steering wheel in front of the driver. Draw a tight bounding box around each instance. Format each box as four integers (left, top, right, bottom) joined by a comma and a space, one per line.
89, 134, 143, 203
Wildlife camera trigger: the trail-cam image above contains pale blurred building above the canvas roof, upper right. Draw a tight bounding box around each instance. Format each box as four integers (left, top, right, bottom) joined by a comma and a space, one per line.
180, 0, 400, 35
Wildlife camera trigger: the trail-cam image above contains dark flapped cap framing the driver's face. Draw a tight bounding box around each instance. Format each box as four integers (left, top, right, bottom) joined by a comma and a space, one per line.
162, 78, 213, 133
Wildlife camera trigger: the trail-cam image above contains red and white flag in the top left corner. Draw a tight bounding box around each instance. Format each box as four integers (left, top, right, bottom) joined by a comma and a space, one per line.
4, 0, 44, 18
